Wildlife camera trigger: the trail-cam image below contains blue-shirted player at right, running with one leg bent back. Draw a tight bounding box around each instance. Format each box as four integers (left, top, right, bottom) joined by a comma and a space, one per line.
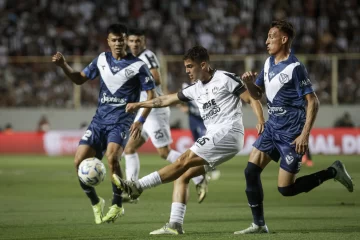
235, 20, 353, 234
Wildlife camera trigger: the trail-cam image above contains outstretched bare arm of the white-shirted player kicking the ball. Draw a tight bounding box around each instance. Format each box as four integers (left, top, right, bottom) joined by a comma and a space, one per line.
126, 93, 181, 113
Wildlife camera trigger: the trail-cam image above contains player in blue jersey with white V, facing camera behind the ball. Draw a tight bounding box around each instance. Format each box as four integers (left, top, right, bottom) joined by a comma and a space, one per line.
52, 24, 155, 224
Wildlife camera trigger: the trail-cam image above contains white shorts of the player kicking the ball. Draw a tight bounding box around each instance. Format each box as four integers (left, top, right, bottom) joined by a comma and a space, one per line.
190, 124, 244, 171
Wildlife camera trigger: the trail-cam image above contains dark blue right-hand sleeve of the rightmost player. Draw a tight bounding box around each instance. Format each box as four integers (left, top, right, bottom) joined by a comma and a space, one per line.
292, 64, 314, 97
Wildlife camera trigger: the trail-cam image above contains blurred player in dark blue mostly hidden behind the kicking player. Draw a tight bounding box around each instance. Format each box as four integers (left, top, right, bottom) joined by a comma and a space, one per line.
178, 82, 221, 181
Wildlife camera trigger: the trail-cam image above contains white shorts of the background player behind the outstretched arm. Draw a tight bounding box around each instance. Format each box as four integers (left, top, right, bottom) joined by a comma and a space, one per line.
135, 107, 173, 148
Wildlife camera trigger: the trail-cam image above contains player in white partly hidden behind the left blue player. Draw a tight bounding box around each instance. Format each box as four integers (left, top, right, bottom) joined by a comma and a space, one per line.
124, 29, 207, 203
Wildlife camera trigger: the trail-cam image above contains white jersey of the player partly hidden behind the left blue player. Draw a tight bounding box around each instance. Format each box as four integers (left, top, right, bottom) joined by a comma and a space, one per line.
137, 49, 169, 114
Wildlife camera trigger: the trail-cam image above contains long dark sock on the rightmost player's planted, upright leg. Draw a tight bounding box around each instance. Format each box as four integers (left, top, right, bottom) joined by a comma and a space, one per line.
245, 162, 265, 226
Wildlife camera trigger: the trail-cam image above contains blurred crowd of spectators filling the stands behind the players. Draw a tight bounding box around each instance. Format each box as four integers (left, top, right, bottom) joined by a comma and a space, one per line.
0, 0, 360, 107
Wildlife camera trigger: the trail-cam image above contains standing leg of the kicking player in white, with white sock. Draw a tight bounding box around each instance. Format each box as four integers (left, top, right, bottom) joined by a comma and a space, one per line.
150, 166, 205, 235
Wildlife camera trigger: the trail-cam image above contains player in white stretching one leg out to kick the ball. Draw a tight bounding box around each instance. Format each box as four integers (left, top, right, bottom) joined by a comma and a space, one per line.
113, 46, 264, 235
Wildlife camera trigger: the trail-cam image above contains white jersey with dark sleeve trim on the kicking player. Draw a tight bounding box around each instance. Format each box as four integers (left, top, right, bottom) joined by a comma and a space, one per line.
178, 70, 246, 132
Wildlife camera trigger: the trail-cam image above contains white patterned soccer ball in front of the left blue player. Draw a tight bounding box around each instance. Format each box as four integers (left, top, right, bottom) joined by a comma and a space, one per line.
78, 157, 106, 187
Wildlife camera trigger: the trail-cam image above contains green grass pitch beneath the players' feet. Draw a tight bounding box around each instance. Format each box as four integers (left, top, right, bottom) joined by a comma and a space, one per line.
0, 154, 360, 240
